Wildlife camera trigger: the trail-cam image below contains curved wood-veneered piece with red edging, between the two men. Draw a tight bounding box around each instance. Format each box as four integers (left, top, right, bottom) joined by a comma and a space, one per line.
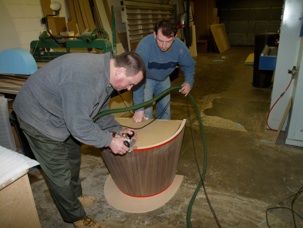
101, 118, 186, 197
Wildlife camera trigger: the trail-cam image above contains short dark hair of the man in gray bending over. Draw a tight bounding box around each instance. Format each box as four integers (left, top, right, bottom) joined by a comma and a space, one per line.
113, 52, 146, 76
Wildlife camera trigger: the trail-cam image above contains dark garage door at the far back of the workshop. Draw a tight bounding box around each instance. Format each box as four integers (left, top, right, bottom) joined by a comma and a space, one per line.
216, 0, 284, 46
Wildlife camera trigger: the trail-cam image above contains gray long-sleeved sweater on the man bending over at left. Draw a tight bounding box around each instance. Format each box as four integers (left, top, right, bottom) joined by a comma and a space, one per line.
13, 53, 121, 148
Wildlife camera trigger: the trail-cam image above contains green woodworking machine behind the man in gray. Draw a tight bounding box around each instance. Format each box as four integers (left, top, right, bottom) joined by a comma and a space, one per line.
30, 28, 113, 62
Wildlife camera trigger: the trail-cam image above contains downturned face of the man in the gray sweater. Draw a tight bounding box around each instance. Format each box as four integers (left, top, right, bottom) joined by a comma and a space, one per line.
112, 67, 143, 91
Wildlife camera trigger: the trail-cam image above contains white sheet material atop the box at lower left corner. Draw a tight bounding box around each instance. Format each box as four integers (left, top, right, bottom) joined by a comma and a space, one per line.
0, 146, 39, 190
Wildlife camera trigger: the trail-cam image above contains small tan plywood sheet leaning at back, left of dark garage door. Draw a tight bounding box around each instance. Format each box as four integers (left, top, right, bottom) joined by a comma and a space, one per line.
210, 24, 230, 53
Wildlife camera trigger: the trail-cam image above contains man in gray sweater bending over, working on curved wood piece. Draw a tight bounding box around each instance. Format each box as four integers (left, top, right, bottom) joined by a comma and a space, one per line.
13, 52, 145, 227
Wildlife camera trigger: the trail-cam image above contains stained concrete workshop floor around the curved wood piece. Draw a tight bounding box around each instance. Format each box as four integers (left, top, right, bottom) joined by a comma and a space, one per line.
29, 47, 303, 228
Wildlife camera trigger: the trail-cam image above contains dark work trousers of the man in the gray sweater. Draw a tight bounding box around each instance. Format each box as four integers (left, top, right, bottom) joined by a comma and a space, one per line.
18, 118, 86, 222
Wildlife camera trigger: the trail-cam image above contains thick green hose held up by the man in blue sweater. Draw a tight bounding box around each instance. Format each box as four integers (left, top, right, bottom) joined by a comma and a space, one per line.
93, 86, 207, 227
